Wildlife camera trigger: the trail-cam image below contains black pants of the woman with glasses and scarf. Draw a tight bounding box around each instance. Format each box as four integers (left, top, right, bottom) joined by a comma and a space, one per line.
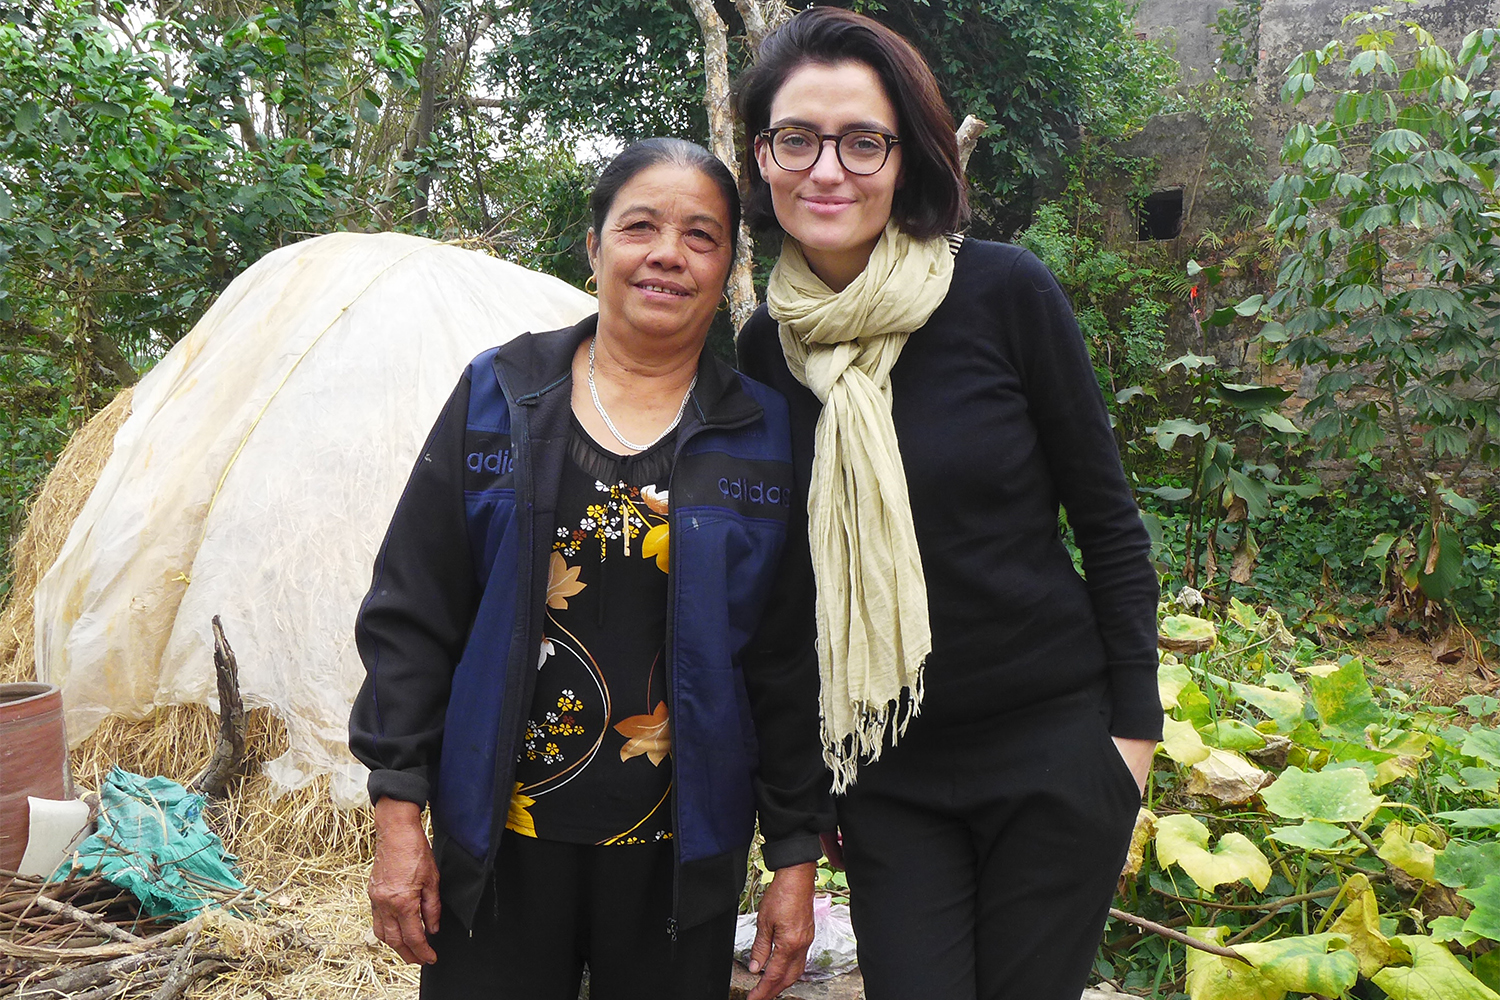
839, 693, 1140, 1000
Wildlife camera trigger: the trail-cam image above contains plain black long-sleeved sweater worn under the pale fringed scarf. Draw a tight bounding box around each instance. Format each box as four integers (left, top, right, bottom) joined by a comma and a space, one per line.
740, 240, 1161, 739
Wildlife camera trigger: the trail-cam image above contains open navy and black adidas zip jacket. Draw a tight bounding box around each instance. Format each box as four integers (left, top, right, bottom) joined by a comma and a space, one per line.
350, 316, 834, 927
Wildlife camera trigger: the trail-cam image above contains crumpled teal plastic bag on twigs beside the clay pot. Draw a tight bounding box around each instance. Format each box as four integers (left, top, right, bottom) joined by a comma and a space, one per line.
53, 768, 246, 921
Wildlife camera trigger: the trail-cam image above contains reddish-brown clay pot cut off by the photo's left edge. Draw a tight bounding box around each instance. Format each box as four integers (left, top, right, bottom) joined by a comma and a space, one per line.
0, 682, 69, 871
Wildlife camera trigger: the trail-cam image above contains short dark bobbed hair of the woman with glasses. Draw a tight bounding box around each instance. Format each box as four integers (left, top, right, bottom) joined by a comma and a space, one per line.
735, 7, 969, 240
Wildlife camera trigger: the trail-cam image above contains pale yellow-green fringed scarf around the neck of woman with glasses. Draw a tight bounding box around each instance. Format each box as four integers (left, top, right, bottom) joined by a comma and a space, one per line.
767, 223, 954, 792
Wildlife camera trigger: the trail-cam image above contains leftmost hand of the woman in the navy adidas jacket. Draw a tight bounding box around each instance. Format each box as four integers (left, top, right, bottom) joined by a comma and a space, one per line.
369, 798, 443, 966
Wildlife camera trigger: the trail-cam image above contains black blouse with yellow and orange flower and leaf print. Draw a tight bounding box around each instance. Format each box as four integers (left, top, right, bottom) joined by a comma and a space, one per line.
506, 418, 677, 844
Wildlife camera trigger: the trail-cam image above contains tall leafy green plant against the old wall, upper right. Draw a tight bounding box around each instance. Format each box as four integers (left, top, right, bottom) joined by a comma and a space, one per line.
1242, 9, 1500, 495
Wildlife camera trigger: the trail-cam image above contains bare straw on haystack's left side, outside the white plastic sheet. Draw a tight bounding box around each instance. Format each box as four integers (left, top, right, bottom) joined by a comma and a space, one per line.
0, 388, 132, 684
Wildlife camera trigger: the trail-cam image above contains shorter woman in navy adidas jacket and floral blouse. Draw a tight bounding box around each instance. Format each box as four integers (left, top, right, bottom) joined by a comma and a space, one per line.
350, 139, 833, 1000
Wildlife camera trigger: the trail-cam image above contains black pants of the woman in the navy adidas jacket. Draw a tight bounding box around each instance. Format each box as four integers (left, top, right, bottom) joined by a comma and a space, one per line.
422, 834, 735, 1000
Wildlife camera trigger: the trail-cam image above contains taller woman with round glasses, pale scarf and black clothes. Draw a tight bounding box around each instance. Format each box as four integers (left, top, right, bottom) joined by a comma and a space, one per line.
740, 7, 1161, 1000
